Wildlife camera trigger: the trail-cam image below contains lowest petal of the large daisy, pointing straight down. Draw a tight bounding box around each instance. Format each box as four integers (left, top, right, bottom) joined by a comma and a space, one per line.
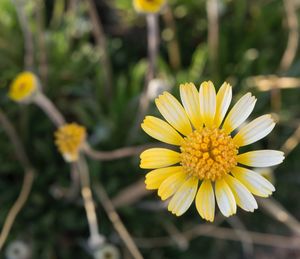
196, 180, 215, 222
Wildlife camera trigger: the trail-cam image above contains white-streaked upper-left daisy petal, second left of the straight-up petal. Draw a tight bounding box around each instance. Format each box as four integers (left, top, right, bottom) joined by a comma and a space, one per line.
155, 92, 192, 135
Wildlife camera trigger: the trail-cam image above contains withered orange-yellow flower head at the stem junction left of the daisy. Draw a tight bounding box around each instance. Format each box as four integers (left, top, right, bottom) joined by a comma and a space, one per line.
55, 123, 86, 162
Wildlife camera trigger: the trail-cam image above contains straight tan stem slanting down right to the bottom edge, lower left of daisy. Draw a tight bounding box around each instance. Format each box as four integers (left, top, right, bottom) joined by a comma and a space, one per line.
94, 183, 143, 259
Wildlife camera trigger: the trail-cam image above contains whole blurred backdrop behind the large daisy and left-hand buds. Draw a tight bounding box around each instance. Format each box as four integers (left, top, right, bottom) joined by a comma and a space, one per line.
0, 0, 300, 259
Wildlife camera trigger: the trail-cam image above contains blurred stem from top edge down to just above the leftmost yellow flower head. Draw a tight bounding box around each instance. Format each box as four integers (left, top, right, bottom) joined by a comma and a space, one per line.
12, 0, 34, 70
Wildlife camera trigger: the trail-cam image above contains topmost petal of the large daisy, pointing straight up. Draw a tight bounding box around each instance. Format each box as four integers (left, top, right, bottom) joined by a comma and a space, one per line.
199, 81, 216, 127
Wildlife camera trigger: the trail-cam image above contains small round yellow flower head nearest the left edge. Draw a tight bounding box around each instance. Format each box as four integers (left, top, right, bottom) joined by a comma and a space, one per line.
8, 72, 39, 102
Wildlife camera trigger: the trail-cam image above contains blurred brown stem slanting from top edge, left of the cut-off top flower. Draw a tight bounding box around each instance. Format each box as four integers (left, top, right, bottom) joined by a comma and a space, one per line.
86, 0, 113, 99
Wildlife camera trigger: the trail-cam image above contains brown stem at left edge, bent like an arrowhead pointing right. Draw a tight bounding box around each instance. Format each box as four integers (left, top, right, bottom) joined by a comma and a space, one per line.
0, 109, 34, 251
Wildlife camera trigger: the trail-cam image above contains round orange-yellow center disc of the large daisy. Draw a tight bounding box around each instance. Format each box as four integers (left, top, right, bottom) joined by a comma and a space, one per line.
180, 127, 238, 181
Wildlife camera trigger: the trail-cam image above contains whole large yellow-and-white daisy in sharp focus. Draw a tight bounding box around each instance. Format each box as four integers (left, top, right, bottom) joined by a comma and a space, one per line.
140, 81, 284, 221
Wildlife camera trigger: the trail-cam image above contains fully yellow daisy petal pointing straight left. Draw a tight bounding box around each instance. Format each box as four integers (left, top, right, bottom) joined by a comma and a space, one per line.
140, 148, 180, 169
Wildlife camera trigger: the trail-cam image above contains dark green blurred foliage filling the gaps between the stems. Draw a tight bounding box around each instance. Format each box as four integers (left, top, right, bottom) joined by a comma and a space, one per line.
0, 0, 300, 259
